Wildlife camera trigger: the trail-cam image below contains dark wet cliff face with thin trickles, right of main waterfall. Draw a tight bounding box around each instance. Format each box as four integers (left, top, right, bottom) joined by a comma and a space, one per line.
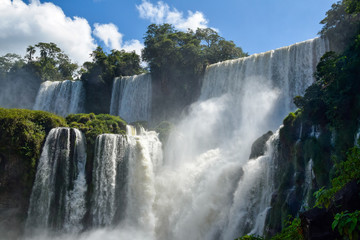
265, 108, 357, 236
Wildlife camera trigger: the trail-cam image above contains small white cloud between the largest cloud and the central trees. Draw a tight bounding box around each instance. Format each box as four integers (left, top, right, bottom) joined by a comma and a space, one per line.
93, 23, 144, 55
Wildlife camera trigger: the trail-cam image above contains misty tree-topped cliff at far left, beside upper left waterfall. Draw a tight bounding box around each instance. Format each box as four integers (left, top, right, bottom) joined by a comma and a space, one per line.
0, 43, 77, 108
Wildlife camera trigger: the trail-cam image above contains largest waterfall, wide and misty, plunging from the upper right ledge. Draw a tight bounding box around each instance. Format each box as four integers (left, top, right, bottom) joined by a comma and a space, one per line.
156, 38, 328, 239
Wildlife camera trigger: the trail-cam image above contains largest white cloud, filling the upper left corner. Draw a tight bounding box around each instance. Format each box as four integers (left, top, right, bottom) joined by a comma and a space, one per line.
0, 0, 96, 64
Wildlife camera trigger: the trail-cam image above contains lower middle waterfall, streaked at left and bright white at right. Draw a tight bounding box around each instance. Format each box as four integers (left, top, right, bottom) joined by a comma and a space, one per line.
91, 126, 162, 235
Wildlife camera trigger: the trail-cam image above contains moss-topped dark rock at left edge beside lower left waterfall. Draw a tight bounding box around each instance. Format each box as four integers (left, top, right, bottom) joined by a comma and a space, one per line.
0, 108, 67, 239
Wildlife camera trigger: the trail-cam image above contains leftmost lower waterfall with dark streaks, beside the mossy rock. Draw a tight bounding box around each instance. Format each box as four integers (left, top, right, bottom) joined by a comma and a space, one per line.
26, 128, 87, 235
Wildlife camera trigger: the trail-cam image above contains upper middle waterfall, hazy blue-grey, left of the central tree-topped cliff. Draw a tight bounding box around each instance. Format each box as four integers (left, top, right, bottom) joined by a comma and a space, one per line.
110, 74, 152, 123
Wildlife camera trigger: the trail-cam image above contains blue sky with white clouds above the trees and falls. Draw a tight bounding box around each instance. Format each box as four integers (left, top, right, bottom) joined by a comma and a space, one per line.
0, 0, 336, 62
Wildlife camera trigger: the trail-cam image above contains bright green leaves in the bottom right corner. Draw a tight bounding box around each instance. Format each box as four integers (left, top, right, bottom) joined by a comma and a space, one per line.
331, 211, 360, 240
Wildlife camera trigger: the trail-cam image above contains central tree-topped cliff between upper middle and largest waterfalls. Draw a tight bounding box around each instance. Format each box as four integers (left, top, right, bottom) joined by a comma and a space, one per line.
142, 24, 247, 121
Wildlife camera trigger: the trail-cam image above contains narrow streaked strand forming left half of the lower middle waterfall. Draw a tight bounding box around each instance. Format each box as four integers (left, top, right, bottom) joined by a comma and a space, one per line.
91, 134, 128, 226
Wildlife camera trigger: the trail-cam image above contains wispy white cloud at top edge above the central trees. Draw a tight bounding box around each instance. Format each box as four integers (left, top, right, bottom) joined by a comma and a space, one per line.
136, 0, 208, 30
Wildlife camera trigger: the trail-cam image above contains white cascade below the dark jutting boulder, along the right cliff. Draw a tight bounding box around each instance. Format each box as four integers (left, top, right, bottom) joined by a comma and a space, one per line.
223, 130, 279, 239
